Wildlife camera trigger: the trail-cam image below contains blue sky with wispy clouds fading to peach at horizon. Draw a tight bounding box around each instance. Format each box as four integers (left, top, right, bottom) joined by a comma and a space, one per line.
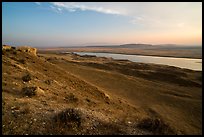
2, 2, 202, 47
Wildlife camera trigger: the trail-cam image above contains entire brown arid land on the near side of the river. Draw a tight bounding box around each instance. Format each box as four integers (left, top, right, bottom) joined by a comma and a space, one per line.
2, 46, 202, 135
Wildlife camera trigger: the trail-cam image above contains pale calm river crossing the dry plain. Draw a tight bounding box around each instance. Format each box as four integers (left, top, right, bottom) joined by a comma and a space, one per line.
74, 52, 202, 71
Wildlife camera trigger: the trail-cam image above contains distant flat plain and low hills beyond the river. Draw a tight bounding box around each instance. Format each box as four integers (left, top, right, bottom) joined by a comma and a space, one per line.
40, 44, 202, 59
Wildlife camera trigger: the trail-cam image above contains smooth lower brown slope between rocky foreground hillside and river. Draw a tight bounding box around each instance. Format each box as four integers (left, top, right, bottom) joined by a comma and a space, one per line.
41, 52, 202, 134
